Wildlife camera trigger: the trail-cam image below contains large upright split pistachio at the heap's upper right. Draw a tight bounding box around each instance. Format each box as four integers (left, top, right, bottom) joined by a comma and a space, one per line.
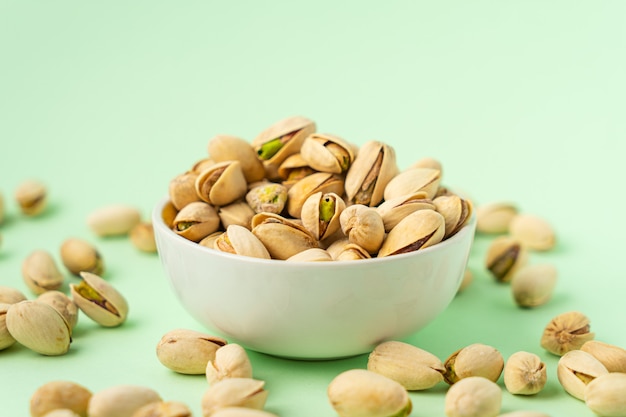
345, 141, 398, 207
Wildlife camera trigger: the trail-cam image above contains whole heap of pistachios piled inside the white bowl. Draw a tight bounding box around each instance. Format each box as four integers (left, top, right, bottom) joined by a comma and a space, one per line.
163, 116, 473, 261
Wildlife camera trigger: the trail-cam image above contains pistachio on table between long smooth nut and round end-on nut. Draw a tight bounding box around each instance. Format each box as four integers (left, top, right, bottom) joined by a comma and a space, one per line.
443, 343, 504, 385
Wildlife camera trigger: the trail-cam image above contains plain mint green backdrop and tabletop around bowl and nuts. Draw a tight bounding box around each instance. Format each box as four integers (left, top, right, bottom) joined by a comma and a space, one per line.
0, 0, 626, 417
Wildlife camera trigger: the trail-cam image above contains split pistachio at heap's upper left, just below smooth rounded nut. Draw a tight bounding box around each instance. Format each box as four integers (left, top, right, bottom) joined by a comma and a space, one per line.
195, 161, 248, 206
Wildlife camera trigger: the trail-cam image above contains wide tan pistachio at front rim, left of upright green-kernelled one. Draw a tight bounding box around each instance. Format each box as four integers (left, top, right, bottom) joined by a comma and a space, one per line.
252, 213, 318, 260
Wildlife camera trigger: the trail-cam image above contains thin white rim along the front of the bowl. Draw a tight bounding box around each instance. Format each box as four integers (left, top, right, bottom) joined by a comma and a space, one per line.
152, 196, 476, 269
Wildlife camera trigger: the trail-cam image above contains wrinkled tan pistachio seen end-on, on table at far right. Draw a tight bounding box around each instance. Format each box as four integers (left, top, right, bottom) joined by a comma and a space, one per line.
541, 311, 595, 356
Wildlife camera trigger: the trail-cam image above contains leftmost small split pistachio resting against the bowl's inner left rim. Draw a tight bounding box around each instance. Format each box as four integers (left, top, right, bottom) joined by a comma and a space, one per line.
173, 201, 220, 242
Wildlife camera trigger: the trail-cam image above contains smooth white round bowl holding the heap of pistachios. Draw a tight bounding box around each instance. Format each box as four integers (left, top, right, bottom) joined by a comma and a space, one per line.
152, 199, 476, 359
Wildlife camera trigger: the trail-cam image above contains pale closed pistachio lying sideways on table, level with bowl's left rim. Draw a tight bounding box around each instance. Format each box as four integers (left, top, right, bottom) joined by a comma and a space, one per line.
87, 204, 141, 236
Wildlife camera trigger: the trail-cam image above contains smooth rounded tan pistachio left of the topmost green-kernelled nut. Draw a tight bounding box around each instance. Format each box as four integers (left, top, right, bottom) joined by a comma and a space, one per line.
208, 135, 265, 182
